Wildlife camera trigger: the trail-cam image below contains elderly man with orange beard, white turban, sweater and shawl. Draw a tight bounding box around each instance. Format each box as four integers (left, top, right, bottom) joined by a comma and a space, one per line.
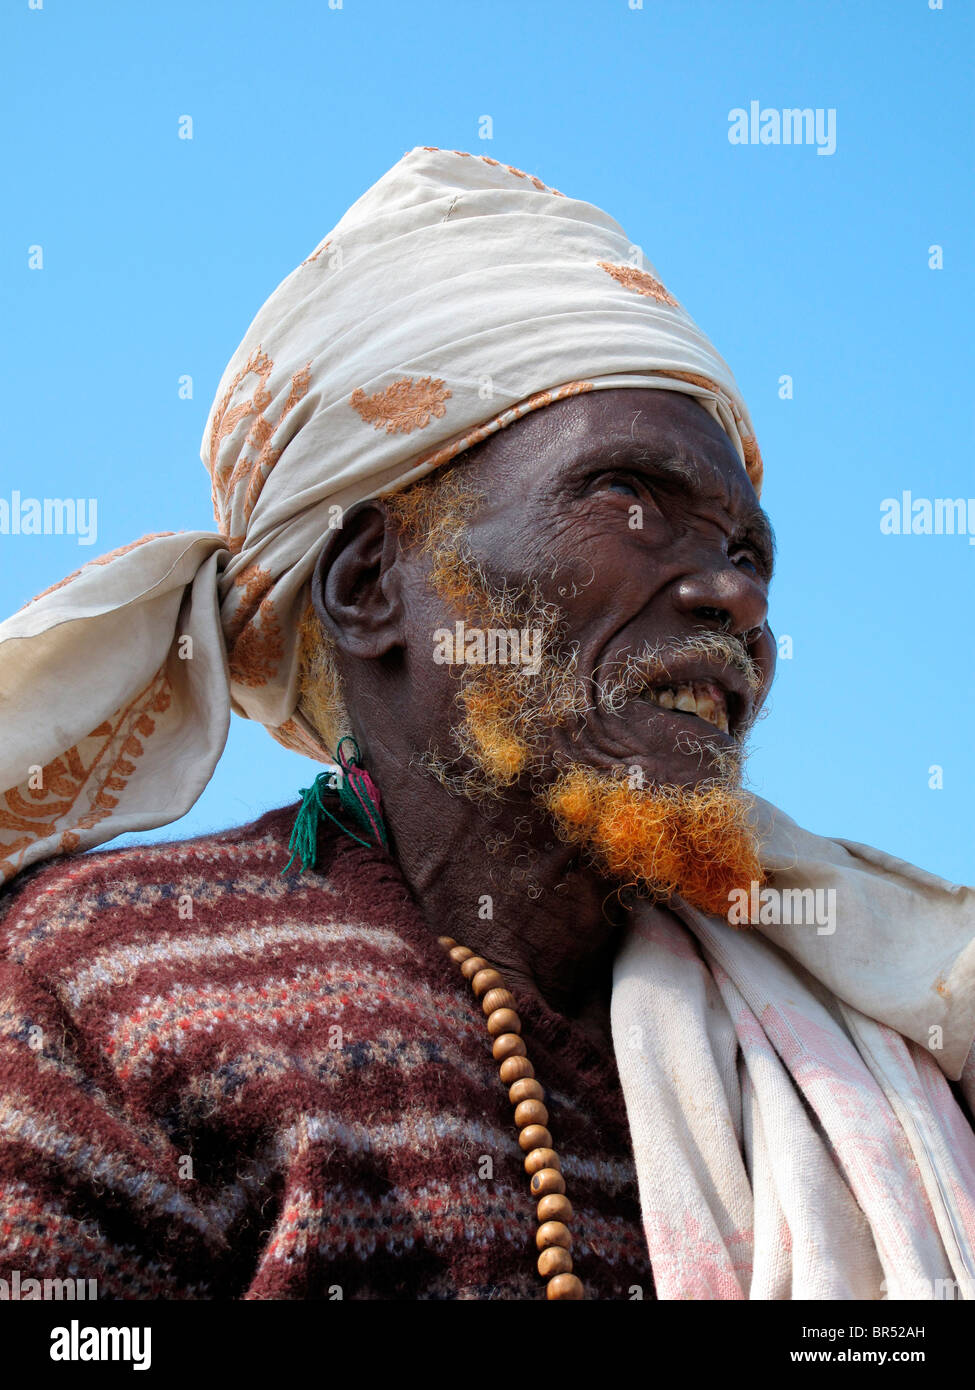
0, 147, 975, 1300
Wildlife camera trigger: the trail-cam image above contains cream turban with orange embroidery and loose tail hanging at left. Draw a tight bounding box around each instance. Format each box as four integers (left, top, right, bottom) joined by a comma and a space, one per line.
0, 146, 762, 878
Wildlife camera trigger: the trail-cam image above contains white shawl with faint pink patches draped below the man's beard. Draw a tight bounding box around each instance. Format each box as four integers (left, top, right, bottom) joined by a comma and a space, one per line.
612, 799, 975, 1300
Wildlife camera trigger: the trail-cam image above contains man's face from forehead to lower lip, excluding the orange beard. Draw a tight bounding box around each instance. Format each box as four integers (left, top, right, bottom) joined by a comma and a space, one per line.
411, 389, 775, 788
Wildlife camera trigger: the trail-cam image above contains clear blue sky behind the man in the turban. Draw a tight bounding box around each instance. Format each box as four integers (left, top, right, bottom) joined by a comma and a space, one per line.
0, 0, 975, 881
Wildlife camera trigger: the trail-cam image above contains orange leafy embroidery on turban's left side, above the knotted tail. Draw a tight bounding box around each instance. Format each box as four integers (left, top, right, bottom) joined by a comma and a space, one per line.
210, 348, 312, 549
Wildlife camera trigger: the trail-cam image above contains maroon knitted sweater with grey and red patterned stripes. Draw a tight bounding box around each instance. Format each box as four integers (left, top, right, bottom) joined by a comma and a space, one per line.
0, 806, 654, 1300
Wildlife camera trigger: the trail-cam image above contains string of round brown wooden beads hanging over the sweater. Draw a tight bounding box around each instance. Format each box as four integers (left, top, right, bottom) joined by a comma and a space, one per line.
438, 937, 586, 1298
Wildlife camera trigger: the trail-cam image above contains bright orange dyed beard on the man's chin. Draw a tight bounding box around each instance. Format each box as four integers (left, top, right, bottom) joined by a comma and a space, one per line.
540, 759, 764, 917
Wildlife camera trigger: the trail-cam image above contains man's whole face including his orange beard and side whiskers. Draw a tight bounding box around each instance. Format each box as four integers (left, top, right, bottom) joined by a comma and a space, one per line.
356, 389, 775, 913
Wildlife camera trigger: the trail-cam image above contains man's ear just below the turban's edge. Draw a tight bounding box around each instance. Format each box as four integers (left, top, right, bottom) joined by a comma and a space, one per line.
312, 498, 403, 659
